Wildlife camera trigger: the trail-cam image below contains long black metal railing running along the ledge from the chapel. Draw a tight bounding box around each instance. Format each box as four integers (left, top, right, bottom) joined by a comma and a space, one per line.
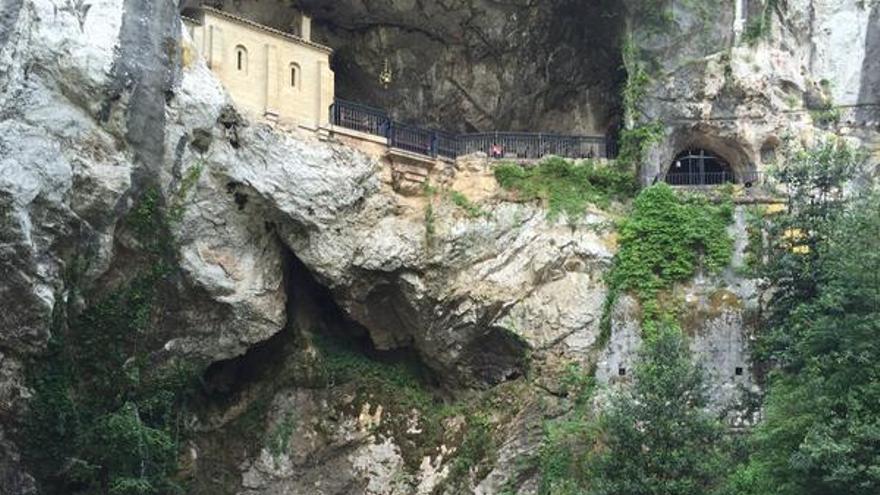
330, 100, 614, 159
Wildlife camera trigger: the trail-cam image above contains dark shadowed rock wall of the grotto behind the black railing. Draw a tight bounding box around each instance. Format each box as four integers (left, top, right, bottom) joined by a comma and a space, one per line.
184, 0, 625, 134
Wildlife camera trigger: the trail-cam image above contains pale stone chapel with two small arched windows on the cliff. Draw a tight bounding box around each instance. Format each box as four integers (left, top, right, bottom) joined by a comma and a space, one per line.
184, 7, 334, 129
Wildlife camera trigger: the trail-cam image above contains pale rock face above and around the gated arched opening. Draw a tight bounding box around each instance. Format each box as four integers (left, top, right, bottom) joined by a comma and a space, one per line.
633, 0, 880, 183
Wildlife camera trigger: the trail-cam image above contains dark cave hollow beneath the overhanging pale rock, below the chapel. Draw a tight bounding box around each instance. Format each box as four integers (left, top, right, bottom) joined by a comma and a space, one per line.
191, 252, 448, 495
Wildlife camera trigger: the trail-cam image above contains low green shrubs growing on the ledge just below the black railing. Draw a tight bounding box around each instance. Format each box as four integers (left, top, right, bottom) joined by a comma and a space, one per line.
495, 157, 636, 219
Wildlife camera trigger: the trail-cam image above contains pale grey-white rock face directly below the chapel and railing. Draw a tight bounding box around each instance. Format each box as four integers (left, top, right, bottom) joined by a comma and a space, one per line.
0, 0, 613, 493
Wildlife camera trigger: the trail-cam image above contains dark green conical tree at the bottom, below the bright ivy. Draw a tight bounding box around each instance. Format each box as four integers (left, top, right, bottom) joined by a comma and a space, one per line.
588, 326, 728, 495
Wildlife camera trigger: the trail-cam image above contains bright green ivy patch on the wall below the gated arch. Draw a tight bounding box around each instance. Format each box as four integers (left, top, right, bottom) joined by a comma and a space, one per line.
607, 184, 733, 330
